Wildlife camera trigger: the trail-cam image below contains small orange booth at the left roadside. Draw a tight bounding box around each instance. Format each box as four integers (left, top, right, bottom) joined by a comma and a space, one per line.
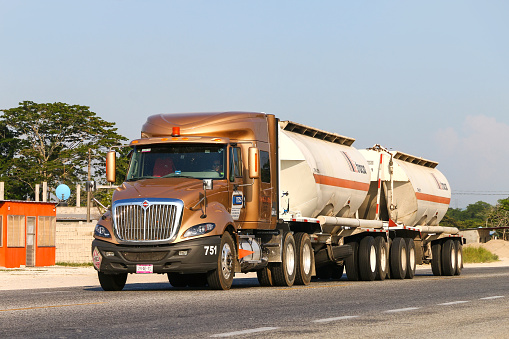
0, 200, 56, 268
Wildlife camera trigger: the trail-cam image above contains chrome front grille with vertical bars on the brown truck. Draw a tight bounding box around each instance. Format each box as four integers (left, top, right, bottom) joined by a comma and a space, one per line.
113, 199, 183, 242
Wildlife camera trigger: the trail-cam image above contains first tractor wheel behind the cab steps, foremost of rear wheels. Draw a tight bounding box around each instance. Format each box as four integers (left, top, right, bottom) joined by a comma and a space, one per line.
271, 232, 297, 286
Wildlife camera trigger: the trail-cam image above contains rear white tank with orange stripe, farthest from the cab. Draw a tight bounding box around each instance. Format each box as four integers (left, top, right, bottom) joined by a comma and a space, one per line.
359, 145, 451, 226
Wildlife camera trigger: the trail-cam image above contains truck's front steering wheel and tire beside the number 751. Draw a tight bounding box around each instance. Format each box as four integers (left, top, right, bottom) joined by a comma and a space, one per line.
207, 232, 237, 290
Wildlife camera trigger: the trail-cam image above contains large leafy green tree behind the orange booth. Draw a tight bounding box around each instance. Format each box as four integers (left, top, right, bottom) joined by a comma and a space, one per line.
0, 101, 127, 199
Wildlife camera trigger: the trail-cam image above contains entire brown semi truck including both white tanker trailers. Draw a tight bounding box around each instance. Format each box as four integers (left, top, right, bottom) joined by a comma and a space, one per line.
92, 112, 462, 290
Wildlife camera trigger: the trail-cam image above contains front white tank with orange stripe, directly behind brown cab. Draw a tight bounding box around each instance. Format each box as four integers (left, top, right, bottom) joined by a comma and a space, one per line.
278, 121, 370, 218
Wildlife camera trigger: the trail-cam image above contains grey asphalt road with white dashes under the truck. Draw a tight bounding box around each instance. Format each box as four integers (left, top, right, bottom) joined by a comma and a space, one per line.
0, 267, 509, 338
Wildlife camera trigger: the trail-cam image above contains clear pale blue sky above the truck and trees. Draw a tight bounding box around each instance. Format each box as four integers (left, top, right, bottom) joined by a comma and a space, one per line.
0, 0, 509, 208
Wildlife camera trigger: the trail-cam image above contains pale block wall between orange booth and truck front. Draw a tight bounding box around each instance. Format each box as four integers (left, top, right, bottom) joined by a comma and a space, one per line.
55, 221, 96, 263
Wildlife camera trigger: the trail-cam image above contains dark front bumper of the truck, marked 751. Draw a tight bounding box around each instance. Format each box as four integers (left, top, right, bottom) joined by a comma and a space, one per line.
92, 236, 221, 274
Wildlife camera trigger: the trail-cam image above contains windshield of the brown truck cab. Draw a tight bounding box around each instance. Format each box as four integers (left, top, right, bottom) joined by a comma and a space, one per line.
126, 143, 226, 181
